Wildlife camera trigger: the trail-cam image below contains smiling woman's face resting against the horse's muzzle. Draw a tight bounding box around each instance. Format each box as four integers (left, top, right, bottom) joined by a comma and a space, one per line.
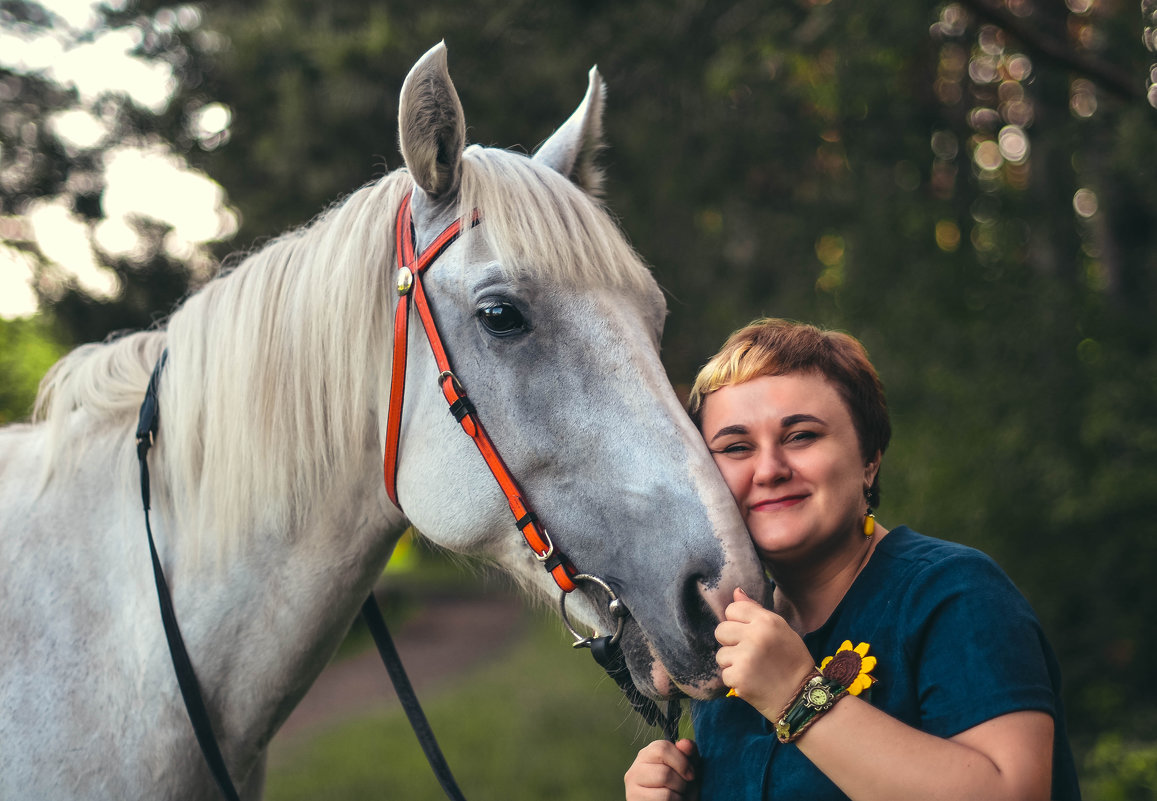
700, 373, 879, 563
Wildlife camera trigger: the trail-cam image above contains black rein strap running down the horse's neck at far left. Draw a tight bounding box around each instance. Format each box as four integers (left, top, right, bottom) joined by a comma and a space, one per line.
137, 350, 241, 801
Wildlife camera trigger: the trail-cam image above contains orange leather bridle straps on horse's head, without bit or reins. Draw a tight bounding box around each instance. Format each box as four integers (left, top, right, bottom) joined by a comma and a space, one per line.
383, 194, 577, 593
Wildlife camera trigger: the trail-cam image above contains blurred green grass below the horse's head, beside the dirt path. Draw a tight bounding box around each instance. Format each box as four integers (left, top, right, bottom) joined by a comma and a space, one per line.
266, 597, 675, 801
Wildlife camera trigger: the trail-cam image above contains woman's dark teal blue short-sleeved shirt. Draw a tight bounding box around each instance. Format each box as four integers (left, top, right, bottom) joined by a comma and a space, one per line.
692, 527, 1081, 801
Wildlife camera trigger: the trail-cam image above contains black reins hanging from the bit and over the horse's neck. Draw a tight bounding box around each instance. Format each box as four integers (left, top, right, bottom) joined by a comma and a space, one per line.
137, 348, 681, 801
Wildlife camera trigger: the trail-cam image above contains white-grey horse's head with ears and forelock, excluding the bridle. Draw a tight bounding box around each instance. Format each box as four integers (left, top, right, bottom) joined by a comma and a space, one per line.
383, 45, 764, 698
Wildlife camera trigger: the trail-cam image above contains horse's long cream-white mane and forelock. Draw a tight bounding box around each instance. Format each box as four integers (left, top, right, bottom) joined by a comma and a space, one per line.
35, 146, 662, 558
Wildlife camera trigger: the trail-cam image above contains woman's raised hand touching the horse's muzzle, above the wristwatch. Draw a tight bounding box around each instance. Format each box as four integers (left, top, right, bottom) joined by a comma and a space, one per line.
715, 589, 815, 722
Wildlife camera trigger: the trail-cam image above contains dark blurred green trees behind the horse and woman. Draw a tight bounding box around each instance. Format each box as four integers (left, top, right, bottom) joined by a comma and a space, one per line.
0, 0, 1157, 798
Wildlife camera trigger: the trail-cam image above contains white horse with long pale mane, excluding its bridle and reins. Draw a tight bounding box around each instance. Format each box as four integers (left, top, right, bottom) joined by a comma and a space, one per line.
0, 45, 762, 801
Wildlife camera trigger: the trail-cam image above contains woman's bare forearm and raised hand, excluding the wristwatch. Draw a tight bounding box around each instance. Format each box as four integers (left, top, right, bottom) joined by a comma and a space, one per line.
716, 594, 1053, 801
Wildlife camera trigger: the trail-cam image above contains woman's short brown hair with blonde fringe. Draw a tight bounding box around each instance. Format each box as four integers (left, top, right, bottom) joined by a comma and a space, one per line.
687, 317, 892, 507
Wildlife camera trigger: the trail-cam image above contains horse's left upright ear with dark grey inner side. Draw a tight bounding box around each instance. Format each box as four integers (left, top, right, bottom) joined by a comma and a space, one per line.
398, 42, 466, 200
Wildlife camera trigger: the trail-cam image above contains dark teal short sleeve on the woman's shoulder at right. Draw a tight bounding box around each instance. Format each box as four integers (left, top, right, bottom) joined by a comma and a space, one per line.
905, 549, 1056, 737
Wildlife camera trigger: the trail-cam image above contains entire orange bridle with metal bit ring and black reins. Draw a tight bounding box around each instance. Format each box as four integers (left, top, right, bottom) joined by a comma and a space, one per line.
137, 189, 681, 801
